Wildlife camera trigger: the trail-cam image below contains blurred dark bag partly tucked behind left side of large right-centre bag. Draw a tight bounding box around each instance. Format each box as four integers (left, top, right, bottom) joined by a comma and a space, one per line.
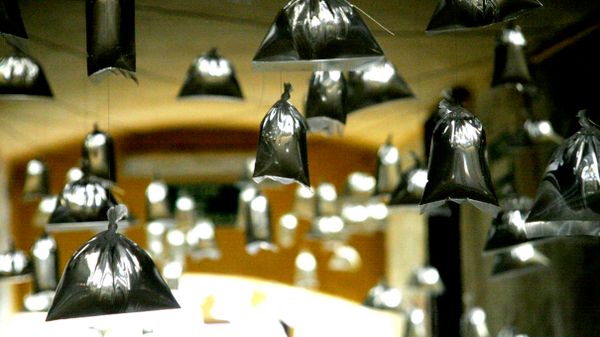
388, 153, 427, 208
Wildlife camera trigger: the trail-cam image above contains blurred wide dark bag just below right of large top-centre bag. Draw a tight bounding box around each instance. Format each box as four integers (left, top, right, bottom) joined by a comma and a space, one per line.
346, 60, 415, 113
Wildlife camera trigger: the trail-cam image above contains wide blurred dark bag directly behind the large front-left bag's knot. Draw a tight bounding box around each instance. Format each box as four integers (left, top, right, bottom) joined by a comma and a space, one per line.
46, 175, 132, 232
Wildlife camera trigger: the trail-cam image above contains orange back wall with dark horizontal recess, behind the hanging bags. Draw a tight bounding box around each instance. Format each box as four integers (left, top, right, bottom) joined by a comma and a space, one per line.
10, 128, 385, 301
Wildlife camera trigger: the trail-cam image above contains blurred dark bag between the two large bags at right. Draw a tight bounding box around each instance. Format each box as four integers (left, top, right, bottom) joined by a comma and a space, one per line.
483, 195, 533, 253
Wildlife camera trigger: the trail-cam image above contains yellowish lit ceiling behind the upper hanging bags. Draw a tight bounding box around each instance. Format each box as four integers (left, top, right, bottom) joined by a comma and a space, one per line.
0, 0, 589, 160
